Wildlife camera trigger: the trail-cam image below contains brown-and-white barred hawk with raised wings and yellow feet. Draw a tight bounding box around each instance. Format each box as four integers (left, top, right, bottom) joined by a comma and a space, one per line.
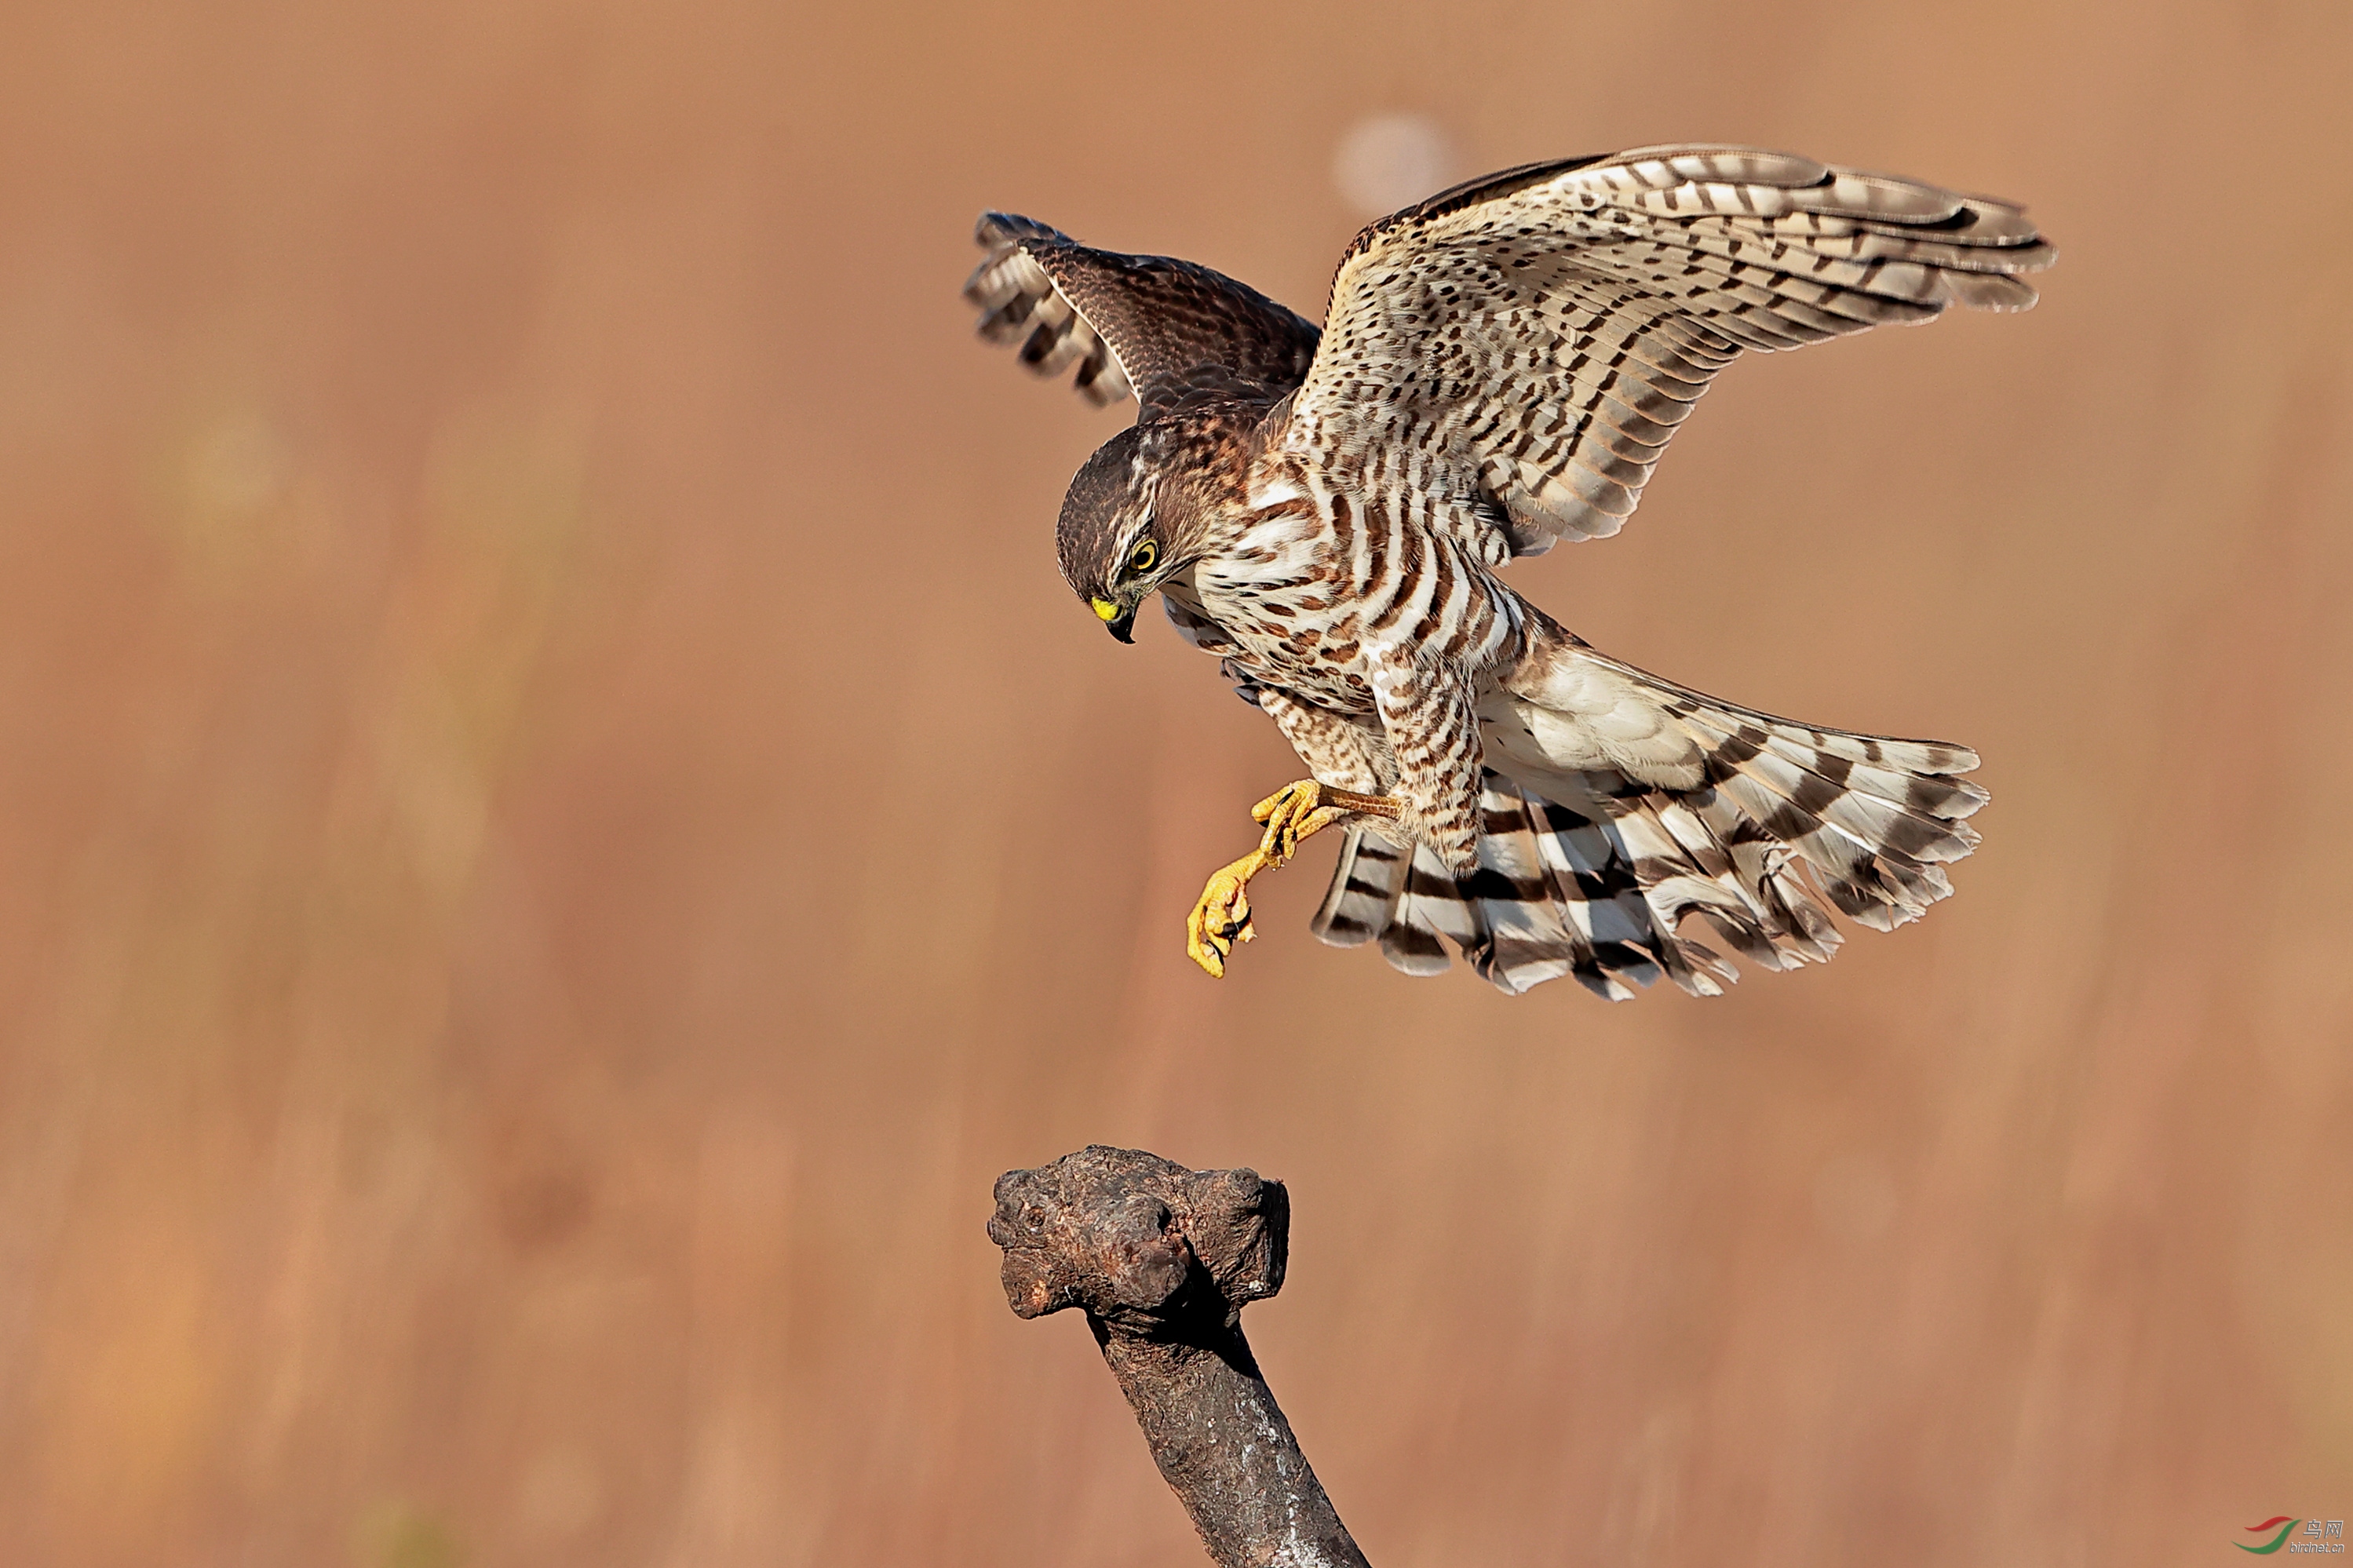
965, 146, 2052, 1001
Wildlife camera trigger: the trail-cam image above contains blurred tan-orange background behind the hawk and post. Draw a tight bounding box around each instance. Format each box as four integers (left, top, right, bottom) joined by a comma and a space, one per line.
0, 0, 2353, 1568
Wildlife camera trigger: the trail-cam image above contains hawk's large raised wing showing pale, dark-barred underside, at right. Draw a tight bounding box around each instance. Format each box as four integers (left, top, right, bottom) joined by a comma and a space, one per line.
1287, 146, 2052, 556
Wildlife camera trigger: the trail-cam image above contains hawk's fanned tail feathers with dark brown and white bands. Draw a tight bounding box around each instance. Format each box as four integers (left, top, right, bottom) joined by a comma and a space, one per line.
1313, 697, 1986, 1001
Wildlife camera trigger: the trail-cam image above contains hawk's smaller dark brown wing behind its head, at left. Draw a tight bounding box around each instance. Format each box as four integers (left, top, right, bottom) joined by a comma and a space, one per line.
965, 212, 1318, 412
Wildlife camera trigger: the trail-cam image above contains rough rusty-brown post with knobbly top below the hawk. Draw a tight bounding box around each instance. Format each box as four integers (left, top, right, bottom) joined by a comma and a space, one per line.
988, 1144, 1370, 1568
